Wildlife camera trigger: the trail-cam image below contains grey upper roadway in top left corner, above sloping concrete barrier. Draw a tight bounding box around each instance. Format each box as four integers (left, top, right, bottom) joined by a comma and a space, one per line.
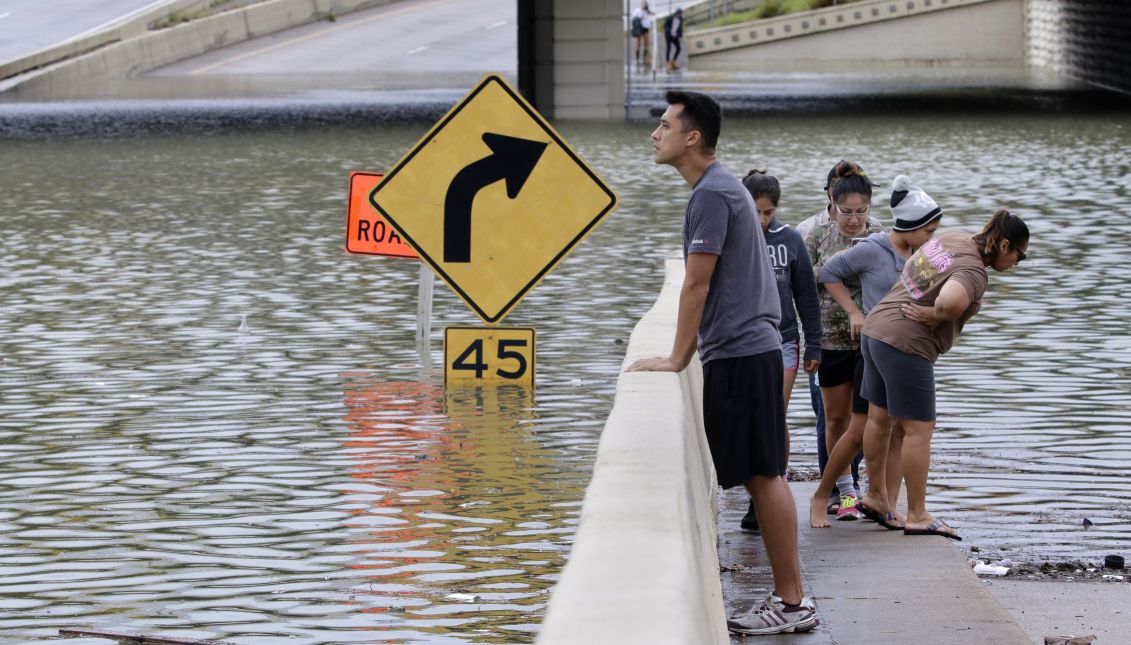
0, 0, 165, 62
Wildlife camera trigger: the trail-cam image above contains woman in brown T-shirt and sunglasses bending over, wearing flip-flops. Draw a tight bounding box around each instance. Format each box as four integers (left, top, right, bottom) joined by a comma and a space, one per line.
861, 209, 1029, 540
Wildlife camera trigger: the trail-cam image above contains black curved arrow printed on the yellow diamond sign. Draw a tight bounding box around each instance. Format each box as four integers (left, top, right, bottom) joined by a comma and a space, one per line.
443, 132, 547, 263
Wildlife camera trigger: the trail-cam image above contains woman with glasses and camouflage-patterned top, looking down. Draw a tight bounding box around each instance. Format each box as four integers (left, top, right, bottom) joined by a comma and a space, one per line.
805, 161, 883, 519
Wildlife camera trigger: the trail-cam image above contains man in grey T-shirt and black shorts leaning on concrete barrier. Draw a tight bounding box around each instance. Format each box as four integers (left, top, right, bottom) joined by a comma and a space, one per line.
628, 91, 820, 634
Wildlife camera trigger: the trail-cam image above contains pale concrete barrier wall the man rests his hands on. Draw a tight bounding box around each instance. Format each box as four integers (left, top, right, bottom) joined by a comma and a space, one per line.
537, 259, 729, 645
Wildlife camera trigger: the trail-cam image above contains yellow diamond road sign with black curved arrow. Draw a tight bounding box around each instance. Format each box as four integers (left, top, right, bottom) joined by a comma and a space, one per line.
370, 75, 616, 324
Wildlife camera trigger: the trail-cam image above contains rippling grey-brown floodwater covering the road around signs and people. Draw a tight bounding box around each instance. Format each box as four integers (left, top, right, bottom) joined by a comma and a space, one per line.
0, 105, 1131, 644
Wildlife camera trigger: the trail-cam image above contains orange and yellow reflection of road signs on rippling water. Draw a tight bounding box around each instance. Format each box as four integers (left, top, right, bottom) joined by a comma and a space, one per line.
340, 371, 545, 626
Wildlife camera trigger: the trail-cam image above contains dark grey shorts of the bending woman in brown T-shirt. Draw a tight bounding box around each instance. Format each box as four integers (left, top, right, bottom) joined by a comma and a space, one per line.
862, 336, 934, 421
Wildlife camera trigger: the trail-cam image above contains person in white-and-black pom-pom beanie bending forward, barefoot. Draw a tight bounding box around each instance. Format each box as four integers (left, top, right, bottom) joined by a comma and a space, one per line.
809, 175, 942, 528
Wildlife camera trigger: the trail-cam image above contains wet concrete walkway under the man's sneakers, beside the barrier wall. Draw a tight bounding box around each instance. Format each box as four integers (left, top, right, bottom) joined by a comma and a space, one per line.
718, 482, 1033, 645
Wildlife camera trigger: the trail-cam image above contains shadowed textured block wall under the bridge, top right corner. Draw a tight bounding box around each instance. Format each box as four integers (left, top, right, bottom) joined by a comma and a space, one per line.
1026, 0, 1131, 93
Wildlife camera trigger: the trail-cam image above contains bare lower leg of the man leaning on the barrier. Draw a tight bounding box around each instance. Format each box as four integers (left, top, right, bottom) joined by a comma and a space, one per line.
746, 475, 802, 604
